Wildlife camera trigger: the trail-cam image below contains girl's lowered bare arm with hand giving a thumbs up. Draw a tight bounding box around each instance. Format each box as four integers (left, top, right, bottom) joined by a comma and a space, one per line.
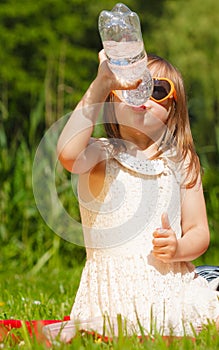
153, 178, 210, 263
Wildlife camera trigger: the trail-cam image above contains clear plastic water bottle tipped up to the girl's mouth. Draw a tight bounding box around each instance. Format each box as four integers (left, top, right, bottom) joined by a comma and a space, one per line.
98, 3, 153, 106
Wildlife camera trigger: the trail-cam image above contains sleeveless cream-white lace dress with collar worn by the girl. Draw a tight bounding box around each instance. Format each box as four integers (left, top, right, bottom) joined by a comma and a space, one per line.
43, 146, 219, 338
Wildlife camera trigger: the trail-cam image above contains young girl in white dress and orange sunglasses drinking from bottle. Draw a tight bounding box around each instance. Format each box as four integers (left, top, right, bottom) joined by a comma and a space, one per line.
53, 50, 219, 336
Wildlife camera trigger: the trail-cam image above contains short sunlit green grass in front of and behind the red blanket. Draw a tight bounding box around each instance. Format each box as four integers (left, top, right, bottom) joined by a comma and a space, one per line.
0, 264, 219, 350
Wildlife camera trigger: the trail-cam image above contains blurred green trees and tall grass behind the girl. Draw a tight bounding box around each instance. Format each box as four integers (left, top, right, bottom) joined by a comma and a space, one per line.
0, 0, 219, 284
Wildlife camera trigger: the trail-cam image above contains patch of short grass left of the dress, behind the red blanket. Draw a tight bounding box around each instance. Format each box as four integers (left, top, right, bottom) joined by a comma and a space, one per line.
0, 267, 81, 321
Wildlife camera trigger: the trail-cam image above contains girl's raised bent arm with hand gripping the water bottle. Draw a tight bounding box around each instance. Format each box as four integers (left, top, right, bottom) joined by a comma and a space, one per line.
57, 50, 140, 173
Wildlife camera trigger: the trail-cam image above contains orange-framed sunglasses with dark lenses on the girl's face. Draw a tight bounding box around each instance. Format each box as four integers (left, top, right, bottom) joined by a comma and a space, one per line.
112, 77, 177, 103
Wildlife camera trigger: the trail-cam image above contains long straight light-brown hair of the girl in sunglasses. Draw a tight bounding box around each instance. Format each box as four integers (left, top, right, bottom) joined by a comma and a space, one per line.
104, 54, 200, 188
